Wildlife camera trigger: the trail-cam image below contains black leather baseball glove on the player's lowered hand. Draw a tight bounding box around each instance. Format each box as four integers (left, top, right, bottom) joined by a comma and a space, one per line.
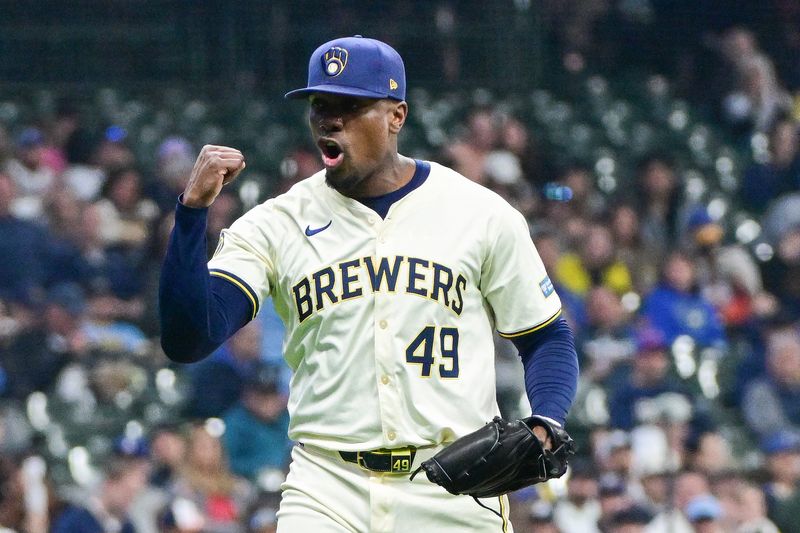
411, 415, 575, 503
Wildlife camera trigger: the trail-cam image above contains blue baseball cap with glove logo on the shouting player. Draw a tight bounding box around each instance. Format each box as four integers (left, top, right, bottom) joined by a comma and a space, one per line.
286, 35, 406, 100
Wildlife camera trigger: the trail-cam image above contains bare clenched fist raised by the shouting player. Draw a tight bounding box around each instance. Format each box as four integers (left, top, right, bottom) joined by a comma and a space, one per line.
183, 144, 245, 207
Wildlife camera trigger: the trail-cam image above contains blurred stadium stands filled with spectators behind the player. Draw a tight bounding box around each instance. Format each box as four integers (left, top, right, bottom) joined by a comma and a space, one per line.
0, 0, 800, 533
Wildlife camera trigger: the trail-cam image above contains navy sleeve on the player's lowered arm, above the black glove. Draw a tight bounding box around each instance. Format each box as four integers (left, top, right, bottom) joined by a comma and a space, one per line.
511, 317, 578, 425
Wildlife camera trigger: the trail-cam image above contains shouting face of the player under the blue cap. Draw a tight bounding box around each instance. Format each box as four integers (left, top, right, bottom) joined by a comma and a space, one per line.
308, 93, 405, 197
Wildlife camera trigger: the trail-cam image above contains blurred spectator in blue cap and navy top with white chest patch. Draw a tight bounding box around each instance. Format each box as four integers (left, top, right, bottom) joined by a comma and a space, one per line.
608, 329, 691, 430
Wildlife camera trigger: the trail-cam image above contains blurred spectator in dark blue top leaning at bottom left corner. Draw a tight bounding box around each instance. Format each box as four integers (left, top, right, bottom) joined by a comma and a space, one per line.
50, 457, 147, 533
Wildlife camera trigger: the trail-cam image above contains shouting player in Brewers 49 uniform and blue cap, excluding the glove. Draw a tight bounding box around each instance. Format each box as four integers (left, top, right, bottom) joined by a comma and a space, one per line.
160, 36, 578, 533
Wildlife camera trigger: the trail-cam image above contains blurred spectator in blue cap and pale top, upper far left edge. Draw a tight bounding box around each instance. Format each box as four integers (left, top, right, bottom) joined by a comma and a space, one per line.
5, 128, 56, 220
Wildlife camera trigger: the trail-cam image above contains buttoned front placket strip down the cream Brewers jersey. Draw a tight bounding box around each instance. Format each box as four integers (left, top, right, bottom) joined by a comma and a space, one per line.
367, 215, 401, 448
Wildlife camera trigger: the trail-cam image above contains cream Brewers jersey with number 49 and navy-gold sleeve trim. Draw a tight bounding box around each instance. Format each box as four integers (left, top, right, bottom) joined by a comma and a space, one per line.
209, 163, 561, 451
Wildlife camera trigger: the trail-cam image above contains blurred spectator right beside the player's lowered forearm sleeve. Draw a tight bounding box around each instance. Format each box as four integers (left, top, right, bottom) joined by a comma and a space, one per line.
575, 287, 636, 383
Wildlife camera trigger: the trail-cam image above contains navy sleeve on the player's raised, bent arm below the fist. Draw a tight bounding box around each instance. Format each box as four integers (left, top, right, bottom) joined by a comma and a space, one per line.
158, 203, 252, 363
